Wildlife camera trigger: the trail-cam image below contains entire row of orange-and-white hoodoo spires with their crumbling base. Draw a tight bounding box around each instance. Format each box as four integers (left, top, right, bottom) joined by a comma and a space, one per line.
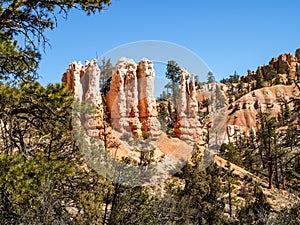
62, 58, 203, 160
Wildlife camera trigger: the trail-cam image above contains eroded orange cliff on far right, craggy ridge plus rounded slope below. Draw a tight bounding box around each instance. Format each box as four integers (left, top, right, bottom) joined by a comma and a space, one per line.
214, 48, 300, 142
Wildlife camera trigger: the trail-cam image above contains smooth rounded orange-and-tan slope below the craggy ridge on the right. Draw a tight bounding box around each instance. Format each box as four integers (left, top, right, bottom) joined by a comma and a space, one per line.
222, 85, 299, 142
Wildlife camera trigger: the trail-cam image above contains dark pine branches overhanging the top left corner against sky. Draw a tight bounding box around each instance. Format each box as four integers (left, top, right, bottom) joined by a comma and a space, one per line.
0, 0, 111, 81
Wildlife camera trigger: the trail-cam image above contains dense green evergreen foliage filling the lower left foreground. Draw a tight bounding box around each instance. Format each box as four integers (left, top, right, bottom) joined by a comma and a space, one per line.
0, 82, 112, 224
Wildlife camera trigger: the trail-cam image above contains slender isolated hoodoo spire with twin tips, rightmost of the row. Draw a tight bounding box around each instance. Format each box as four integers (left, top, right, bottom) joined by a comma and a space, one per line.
174, 69, 203, 145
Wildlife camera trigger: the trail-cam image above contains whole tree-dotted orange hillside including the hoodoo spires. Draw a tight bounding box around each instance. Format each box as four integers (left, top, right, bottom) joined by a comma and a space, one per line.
55, 50, 300, 224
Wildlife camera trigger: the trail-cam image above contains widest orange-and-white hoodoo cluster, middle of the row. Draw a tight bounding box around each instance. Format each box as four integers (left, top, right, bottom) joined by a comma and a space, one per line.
106, 58, 160, 140
